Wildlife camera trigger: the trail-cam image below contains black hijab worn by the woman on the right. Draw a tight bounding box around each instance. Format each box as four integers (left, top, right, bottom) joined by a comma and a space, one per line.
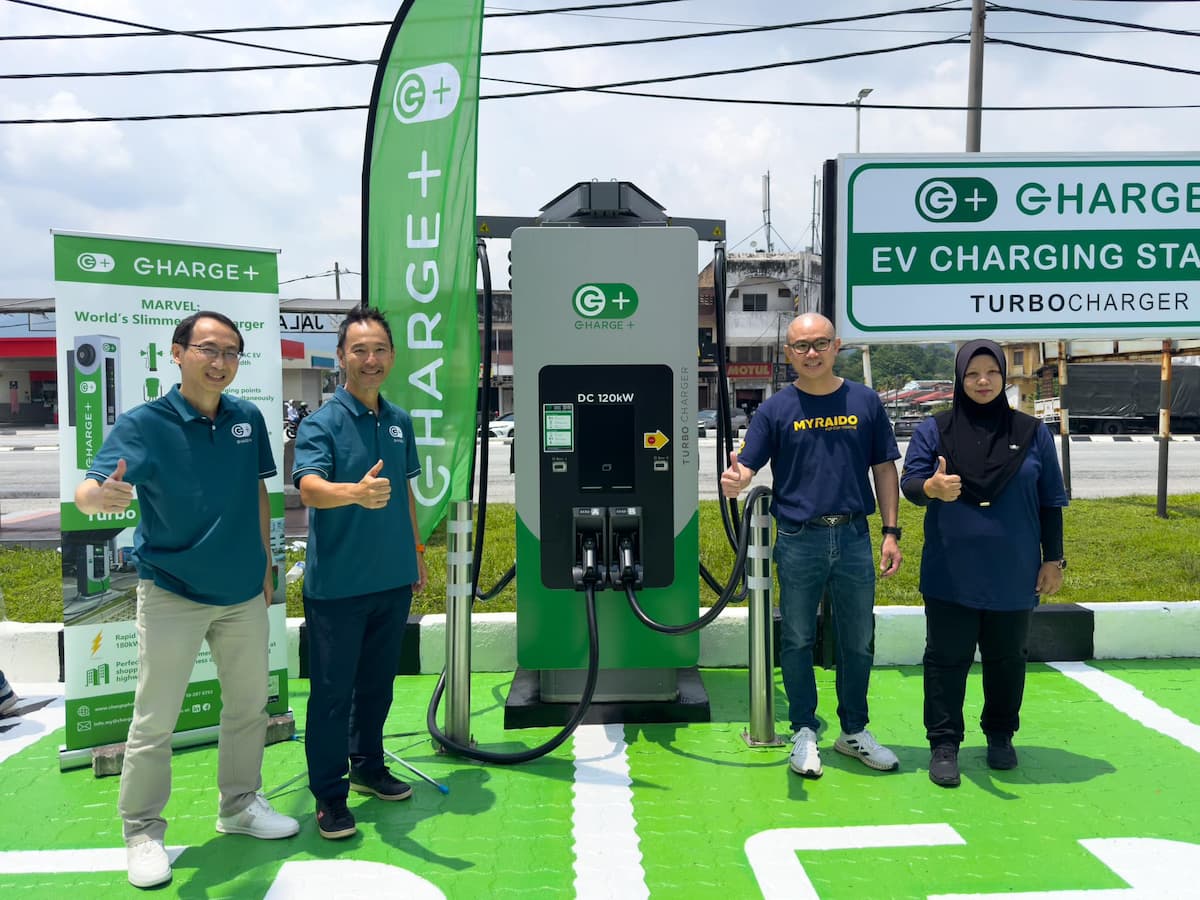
935, 341, 1040, 506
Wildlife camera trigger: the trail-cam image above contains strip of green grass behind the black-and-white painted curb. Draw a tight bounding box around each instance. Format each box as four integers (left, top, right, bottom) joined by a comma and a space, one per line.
0, 493, 1200, 622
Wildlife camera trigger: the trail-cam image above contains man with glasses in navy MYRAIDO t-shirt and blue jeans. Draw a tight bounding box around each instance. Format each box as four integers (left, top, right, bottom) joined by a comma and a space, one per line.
721, 313, 901, 778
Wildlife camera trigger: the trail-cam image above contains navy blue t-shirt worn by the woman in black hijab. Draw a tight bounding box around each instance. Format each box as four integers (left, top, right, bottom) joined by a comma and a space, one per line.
900, 416, 1067, 611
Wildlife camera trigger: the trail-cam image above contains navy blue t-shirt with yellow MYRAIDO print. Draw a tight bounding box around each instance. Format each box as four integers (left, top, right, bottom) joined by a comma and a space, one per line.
738, 379, 900, 524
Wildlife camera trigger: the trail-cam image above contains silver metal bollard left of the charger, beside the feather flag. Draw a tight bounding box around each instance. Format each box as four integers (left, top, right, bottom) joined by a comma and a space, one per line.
445, 500, 474, 745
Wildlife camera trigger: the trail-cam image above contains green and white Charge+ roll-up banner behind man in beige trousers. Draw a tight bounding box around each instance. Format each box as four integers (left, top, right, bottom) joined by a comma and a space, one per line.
54, 232, 288, 768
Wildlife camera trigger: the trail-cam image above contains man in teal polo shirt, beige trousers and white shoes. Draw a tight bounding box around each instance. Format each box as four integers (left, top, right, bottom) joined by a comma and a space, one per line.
76, 312, 300, 888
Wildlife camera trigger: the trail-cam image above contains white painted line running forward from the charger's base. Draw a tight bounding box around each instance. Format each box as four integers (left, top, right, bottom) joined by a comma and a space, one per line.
571, 724, 650, 900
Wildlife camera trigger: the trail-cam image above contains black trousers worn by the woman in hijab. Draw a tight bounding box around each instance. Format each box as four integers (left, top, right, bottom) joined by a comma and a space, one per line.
924, 596, 1033, 746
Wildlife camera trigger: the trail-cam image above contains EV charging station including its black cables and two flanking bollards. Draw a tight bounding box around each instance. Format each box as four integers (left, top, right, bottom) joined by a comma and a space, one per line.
426, 181, 780, 764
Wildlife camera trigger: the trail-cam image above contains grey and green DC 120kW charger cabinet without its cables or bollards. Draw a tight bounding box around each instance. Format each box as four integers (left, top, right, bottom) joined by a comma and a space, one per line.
482, 182, 724, 727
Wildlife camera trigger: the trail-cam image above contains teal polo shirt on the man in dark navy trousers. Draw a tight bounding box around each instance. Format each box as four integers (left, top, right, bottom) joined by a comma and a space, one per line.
292, 388, 421, 601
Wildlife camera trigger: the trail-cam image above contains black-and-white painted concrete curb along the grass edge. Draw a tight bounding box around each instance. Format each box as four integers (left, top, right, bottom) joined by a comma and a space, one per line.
0, 600, 1200, 684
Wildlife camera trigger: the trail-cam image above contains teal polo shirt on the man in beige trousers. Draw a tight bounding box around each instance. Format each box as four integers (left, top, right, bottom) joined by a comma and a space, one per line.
88, 384, 275, 606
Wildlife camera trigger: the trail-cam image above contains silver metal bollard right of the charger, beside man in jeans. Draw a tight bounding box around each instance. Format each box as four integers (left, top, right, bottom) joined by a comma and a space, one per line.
742, 494, 784, 746
